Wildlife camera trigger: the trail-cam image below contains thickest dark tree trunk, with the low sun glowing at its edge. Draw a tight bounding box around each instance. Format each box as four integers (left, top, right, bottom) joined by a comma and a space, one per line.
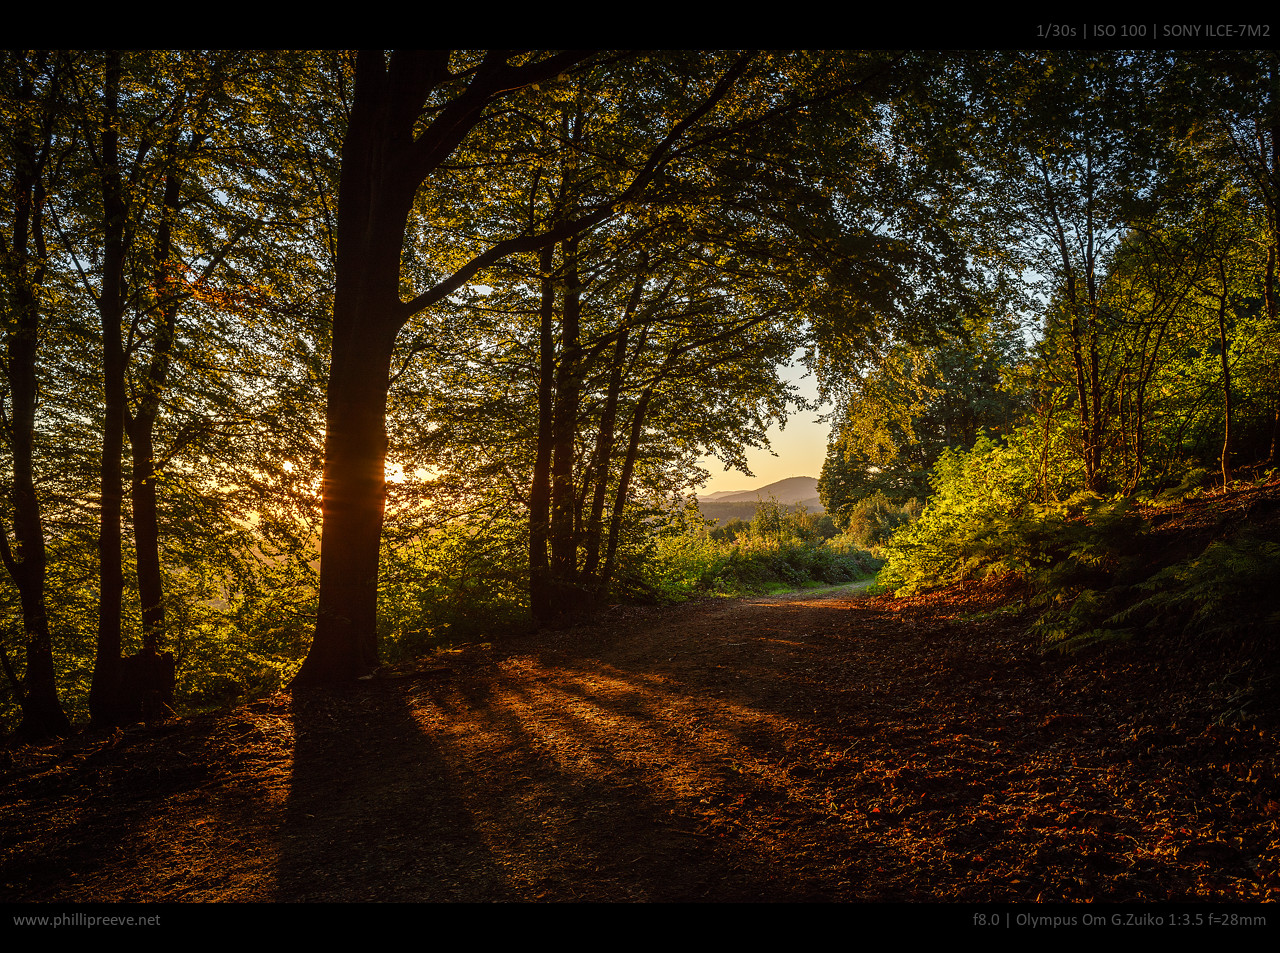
294, 54, 420, 684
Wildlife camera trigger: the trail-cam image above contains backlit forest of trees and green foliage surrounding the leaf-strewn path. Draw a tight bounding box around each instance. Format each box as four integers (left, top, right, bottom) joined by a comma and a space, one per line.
0, 50, 1280, 767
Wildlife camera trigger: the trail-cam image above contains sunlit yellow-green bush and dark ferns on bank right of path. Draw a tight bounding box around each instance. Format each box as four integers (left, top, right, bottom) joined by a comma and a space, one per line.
877, 432, 1280, 652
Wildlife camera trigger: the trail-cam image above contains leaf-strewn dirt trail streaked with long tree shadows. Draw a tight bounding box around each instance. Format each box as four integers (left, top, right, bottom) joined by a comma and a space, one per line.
0, 583, 1280, 902
